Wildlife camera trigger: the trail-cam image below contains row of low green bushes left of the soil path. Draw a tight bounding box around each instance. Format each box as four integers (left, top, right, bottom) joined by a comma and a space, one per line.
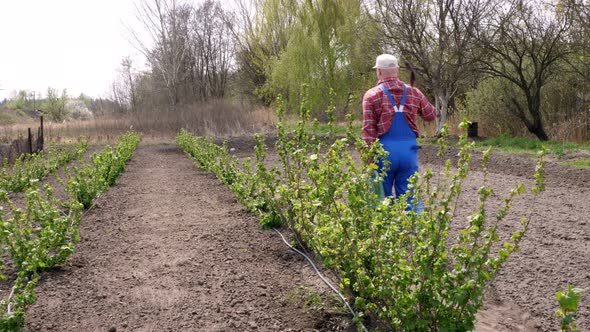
0, 133, 140, 331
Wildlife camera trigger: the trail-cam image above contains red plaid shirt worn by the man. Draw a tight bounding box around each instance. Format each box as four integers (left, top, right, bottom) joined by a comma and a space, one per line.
361, 79, 436, 145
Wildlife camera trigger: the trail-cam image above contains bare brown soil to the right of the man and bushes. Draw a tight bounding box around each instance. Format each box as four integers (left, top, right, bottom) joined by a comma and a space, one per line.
420, 146, 590, 331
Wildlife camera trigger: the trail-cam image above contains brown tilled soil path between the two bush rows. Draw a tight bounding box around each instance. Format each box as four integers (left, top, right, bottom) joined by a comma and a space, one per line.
24, 145, 355, 331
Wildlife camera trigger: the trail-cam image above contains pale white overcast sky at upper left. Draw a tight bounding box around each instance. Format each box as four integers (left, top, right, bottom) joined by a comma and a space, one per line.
0, 0, 155, 100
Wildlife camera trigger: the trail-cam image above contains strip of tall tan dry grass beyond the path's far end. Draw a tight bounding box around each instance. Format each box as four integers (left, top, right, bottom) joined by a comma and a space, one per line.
0, 101, 276, 144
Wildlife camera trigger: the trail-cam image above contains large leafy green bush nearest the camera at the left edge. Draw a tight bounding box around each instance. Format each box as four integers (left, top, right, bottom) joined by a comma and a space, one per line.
0, 185, 81, 331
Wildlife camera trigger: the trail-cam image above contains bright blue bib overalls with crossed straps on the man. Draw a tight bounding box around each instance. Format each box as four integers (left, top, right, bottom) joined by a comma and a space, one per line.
379, 85, 422, 212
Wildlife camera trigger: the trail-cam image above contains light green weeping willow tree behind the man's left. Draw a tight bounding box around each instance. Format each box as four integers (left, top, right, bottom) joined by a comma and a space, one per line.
267, 0, 381, 115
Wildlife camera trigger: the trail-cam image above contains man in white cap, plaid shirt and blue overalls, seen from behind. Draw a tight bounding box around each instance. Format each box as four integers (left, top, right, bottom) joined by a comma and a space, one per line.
361, 54, 436, 212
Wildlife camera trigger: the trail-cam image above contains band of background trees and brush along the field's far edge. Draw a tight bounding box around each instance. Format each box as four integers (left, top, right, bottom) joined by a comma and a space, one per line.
0, 0, 590, 142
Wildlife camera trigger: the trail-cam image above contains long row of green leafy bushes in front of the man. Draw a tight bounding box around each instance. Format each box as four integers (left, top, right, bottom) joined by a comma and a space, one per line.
177, 87, 544, 331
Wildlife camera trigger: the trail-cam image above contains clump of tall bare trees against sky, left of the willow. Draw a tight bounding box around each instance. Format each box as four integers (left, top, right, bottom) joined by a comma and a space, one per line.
130, 0, 234, 110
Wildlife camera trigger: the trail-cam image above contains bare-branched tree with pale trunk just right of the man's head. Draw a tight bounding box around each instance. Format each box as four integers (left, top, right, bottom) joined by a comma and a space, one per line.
371, 0, 495, 131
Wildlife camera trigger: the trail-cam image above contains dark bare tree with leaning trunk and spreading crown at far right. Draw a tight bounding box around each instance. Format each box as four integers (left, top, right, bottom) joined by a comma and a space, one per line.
477, 0, 571, 140
